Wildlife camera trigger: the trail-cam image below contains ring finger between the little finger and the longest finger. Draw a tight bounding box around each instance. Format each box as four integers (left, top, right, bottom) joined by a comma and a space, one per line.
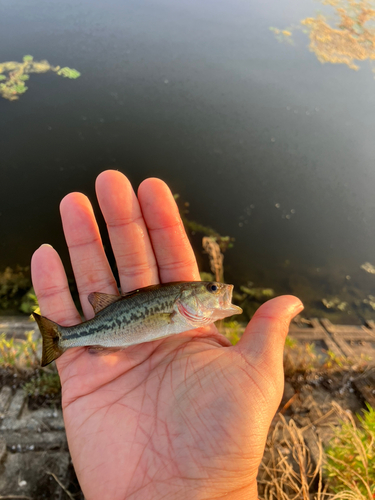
60, 193, 118, 319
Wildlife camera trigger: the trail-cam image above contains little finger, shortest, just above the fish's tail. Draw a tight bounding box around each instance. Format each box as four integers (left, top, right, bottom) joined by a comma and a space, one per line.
31, 245, 81, 326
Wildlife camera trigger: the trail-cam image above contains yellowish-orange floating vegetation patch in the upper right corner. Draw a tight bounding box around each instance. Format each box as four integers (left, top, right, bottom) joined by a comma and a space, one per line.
270, 0, 375, 77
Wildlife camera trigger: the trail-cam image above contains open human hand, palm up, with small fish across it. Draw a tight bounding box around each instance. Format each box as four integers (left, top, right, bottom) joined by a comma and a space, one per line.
32, 170, 303, 500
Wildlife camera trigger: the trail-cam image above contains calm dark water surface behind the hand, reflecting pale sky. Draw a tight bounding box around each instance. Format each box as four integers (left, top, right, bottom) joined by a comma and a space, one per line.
0, 0, 375, 319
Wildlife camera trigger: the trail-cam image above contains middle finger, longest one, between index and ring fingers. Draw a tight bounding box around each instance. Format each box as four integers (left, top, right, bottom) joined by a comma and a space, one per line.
96, 170, 159, 291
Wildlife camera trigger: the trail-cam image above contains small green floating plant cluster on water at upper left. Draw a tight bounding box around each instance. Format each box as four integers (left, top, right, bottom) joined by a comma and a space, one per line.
0, 55, 81, 101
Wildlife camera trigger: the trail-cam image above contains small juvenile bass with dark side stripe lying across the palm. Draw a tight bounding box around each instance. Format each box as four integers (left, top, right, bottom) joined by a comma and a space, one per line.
33, 281, 242, 366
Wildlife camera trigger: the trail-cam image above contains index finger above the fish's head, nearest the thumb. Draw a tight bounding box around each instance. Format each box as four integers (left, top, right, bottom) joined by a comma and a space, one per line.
138, 178, 200, 283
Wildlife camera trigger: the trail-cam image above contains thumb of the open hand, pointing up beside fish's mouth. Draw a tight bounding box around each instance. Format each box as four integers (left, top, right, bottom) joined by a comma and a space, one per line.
236, 295, 303, 368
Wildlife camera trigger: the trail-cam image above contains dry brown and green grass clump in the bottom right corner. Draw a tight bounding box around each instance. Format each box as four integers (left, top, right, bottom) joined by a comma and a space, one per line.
258, 403, 375, 500
